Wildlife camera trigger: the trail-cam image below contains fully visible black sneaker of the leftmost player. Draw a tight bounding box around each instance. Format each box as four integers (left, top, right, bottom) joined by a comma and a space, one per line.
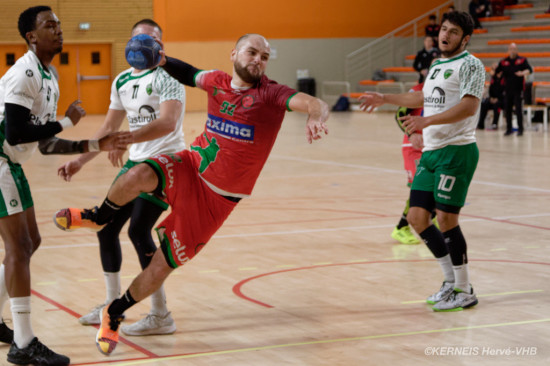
8, 337, 71, 366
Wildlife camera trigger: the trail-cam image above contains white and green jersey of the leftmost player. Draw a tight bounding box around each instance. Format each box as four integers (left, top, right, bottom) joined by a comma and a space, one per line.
0, 51, 59, 164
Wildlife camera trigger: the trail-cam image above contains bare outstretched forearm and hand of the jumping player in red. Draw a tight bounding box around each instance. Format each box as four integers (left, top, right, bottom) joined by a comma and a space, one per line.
288, 93, 329, 144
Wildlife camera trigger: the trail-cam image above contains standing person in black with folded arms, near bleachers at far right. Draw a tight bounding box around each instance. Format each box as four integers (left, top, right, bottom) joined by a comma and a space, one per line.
495, 43, 533, 136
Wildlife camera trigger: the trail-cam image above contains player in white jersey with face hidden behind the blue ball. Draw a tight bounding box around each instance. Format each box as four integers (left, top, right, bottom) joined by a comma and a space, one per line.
59, 19, 185, 336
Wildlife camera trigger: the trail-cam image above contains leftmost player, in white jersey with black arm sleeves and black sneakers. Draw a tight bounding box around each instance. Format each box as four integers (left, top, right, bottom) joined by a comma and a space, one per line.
0, 6, 130, 365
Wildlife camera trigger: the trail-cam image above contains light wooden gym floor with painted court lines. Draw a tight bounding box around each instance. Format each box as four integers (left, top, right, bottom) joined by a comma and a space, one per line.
0, 112, 550, 366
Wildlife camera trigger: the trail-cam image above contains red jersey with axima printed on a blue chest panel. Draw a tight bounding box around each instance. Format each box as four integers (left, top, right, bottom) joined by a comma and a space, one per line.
190, 71, 297, 197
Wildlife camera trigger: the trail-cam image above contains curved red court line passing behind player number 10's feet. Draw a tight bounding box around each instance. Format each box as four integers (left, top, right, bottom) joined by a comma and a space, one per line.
233, 259, 550, 309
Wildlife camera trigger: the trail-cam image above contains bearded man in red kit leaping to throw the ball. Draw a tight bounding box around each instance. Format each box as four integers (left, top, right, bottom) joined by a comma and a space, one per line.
54, 34, 329, 355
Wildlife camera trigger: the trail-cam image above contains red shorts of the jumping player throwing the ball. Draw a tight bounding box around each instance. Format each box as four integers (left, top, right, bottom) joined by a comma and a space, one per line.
146, 150, 237, 268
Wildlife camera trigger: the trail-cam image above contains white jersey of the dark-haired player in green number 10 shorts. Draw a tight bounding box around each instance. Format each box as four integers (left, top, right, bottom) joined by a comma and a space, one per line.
422, 51, 485, 151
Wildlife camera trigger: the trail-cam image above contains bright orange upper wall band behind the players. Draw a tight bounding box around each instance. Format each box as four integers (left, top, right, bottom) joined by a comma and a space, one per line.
153, 0, 445, 42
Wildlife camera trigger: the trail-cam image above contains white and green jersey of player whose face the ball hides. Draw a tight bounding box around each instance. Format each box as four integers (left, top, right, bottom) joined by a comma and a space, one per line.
109, 67, 185, 162
